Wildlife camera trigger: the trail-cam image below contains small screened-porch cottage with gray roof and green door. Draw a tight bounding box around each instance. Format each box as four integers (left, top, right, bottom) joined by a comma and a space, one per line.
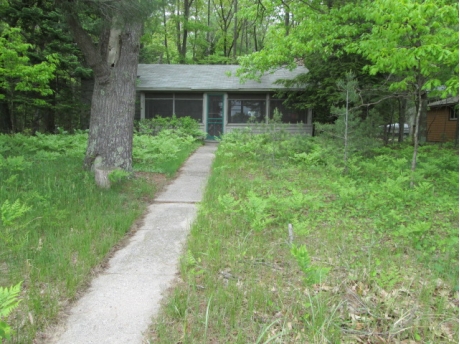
137, 64, 313, 139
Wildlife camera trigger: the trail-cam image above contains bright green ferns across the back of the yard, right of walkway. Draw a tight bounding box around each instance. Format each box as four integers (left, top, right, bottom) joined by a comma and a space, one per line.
218, 132, 459, 280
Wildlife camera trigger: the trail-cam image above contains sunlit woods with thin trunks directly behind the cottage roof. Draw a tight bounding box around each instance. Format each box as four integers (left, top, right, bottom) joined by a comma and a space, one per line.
141, 0, 274, 64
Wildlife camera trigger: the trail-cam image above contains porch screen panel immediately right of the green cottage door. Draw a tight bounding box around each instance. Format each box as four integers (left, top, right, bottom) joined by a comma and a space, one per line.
228, 94, 266, 123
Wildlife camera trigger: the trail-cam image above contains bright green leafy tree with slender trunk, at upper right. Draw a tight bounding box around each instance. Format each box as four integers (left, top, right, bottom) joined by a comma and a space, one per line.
347, 0, 459, 177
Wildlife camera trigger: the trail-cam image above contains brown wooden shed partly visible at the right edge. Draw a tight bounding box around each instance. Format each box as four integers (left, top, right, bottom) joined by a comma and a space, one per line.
427, 96, 458, 142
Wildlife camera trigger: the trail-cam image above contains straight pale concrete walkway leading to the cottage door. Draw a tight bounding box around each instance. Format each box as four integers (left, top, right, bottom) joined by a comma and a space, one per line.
52, 143, 217, 344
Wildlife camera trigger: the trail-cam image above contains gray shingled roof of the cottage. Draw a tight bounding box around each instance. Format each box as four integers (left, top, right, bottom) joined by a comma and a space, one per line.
137, 64, 308, 91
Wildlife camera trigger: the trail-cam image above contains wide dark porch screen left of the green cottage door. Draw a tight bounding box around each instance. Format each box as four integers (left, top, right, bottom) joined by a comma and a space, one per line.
145, 93, 203, 123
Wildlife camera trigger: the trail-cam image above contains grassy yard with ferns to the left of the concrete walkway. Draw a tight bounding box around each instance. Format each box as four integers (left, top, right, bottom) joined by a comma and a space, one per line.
0, 117, 201, 343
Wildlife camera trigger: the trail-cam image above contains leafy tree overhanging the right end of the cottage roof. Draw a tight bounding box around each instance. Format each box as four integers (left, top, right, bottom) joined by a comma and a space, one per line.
235, 0, 384, 112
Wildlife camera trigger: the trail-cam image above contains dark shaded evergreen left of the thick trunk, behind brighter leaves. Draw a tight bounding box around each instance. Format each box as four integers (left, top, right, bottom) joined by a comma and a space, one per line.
0, 0, 91, 133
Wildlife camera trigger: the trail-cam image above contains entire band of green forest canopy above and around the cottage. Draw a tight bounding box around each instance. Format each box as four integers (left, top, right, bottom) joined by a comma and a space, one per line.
0, 0, 458, 133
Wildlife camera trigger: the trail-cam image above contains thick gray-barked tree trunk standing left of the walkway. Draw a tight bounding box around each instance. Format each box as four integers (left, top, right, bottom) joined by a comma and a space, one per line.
63, 14, 142, 171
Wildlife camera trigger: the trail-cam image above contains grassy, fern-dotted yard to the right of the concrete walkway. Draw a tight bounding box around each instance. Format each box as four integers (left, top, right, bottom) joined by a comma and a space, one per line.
147, 131, 459, 344
